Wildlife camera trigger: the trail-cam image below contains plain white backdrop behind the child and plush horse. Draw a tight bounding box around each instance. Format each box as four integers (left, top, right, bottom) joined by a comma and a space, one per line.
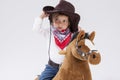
0, 0, 120, 80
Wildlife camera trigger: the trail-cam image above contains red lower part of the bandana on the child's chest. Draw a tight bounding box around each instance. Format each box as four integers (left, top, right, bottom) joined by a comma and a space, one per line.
54, 33, 71, 49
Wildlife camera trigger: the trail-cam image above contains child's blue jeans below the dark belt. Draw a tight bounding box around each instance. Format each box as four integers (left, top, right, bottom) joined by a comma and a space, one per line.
39, 64, 59, 80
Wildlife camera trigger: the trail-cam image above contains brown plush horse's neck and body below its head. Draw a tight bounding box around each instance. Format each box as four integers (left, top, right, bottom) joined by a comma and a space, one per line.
53, 39, 92, 80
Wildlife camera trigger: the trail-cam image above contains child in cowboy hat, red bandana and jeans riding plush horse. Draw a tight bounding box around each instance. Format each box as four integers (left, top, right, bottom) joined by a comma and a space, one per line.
33, 0, 80, 80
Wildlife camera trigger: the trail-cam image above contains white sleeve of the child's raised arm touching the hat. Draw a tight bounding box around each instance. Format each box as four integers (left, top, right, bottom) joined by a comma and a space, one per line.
32, 17, 50, 36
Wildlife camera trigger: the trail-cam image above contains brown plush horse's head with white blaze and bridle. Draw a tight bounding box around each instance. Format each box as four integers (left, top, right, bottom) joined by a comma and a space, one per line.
61, 30, 101, 65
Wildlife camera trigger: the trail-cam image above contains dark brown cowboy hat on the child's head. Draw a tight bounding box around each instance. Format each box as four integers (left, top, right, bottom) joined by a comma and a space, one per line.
43, 0, 80, 32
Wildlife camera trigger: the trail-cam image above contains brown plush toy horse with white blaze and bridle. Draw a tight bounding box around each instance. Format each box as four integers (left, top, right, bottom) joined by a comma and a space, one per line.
53, 30, 101, 80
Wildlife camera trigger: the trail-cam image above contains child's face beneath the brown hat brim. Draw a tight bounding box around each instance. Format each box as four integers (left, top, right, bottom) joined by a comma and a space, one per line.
52, 14, 69, 31
